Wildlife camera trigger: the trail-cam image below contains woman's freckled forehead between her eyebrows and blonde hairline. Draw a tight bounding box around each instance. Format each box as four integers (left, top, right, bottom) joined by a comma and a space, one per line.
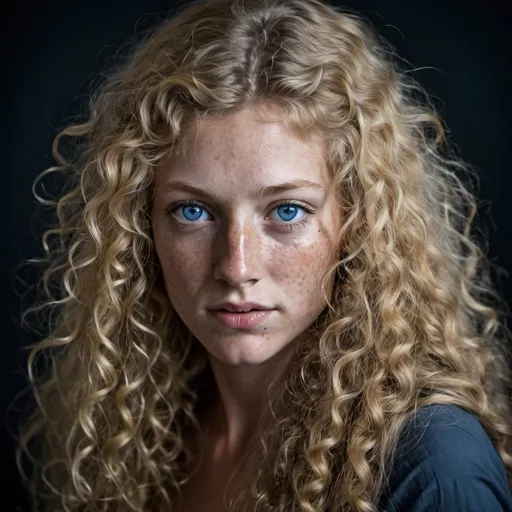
156, 108, 330, 187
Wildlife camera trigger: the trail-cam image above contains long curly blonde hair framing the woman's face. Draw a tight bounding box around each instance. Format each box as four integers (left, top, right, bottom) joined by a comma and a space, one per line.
18, 0, 512, 512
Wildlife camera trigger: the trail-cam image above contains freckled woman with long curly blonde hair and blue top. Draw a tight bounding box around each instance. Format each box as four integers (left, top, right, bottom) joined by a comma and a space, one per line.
20, 0, 512, 512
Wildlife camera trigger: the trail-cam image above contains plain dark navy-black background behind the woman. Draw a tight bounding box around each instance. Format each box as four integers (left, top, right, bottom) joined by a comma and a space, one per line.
0, 0, 512, 512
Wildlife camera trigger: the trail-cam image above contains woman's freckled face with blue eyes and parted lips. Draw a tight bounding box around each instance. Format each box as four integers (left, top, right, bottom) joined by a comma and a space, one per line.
151, 107, 340, 365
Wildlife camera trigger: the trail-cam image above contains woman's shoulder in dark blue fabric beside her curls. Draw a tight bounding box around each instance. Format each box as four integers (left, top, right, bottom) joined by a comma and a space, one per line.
379, 405, 512, 512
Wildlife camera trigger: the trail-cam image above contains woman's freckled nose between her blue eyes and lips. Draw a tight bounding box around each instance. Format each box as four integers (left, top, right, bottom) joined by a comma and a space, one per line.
214, 221, 263, 288
